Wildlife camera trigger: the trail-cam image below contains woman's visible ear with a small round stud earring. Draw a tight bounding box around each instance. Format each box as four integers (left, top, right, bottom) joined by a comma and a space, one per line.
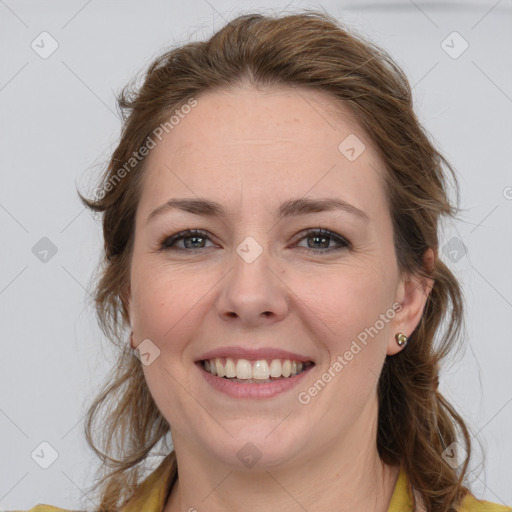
387, 248, 437, 355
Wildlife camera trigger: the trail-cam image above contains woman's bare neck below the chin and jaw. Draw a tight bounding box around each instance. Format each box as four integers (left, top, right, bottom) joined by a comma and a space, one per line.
164, 400, 399, 512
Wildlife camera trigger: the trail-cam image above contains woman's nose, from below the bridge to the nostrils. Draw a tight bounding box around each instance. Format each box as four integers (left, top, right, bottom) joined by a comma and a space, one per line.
216, 244, 289, 327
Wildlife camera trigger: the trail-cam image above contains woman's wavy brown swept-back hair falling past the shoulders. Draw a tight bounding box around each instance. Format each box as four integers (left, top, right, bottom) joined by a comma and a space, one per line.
80, 10, 471, 512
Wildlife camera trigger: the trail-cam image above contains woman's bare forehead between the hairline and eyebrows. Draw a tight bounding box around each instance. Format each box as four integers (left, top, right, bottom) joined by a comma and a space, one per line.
139, 83, 385, 220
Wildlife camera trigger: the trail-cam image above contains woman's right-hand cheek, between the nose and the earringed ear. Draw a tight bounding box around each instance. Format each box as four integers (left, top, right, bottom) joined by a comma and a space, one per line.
296, 264, 394, 394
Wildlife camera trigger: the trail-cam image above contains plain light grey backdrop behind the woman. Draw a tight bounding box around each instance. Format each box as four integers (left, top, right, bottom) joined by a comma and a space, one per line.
0, 0, 512, 510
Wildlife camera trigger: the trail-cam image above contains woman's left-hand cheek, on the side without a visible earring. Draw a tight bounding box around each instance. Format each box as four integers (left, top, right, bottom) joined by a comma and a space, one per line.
131, 258, 208, 416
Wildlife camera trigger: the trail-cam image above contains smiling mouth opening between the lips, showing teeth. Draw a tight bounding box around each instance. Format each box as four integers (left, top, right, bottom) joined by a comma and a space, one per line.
197, 357, 315, 384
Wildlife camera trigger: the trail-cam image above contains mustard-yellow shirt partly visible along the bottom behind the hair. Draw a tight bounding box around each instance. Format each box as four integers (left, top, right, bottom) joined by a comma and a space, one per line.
23, 467, 512, 512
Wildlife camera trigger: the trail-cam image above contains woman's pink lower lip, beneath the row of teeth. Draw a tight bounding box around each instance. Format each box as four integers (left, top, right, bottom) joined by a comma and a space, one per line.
196, 362, 315, 399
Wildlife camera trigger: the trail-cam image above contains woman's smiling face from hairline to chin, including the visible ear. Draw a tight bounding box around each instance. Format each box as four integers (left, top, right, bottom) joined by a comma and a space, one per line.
127, 87, 425, 467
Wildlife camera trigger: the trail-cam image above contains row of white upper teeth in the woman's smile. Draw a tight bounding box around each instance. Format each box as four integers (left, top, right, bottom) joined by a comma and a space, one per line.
203, 357, 311, 380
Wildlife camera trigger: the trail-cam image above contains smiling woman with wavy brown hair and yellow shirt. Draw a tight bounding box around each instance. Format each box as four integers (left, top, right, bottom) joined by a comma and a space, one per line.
32, 11, 511, 512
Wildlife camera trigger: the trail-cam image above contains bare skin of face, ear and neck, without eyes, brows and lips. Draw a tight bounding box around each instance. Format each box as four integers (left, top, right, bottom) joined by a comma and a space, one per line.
126, 85, 433, 512
